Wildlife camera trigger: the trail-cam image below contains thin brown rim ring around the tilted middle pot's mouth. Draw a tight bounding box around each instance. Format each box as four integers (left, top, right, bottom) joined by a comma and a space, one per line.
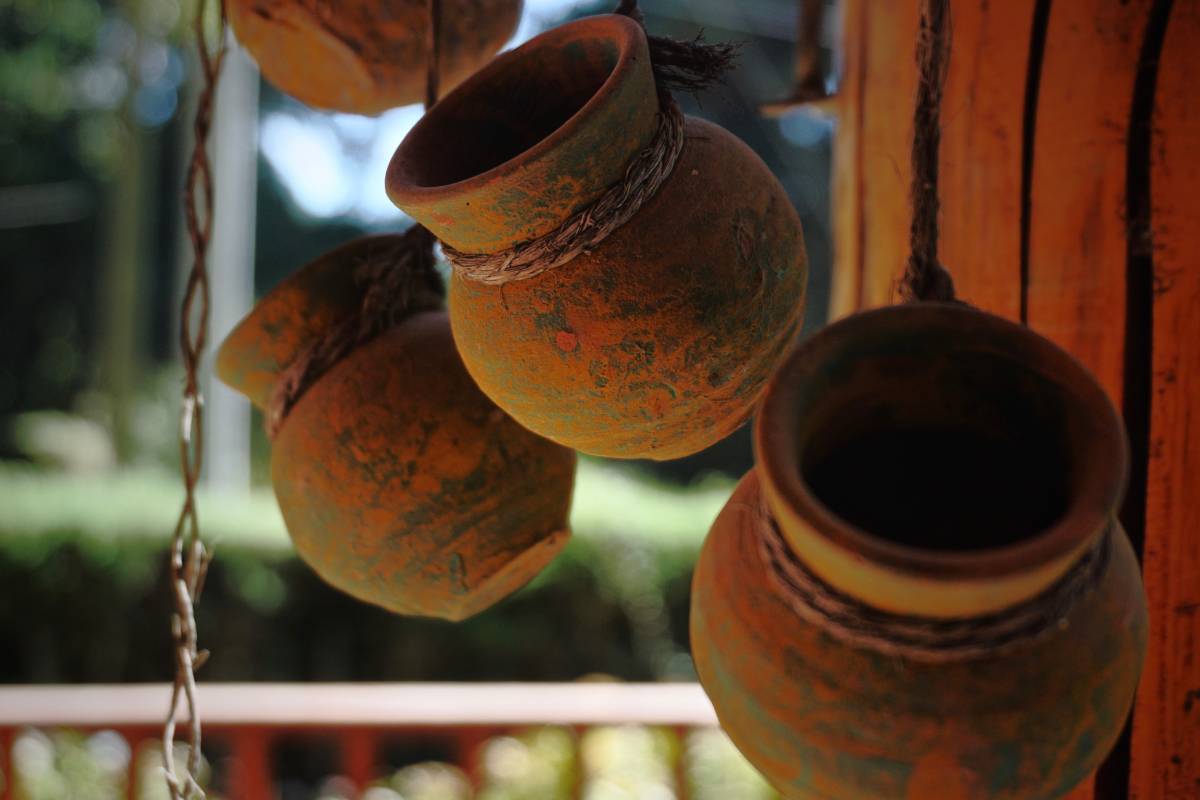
384, 14, 647, 203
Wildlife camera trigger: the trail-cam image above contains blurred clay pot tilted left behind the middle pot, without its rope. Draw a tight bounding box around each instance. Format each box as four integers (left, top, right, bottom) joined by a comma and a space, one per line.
216, 236, 575, 620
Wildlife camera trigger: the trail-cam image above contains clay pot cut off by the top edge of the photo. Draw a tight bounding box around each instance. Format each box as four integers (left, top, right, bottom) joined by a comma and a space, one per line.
226, 0, 522, 114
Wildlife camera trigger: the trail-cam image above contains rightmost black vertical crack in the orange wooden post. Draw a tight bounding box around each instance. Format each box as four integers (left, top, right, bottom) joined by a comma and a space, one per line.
1096, 0, 1174, 800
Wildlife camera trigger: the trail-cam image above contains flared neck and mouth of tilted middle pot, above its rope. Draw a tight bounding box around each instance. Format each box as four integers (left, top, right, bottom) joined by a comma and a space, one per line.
386, 14, 659, 253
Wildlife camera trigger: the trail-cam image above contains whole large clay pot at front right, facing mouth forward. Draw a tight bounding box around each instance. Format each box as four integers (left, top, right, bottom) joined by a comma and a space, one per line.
691, 305, 1146, 800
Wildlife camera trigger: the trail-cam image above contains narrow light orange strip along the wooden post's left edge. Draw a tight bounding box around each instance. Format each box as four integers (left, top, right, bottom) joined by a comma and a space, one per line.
829, 0, 866, 320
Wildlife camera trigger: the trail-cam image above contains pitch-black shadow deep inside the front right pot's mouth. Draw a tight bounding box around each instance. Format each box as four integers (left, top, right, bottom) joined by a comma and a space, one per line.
799, 404, 1075, 552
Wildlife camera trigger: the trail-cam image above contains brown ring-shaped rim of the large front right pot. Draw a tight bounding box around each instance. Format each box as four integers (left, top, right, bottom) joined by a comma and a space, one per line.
754, 302, 1129, 582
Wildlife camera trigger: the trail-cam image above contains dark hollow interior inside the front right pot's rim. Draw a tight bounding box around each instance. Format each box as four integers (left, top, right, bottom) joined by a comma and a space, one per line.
797, 350, 1075, 551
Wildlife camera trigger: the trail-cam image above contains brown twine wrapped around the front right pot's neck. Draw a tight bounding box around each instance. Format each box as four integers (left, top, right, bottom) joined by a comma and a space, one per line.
755, 503, 1112, 663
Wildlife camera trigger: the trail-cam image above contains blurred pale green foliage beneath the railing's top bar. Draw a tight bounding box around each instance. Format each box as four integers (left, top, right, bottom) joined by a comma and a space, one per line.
7, 726, 779, 800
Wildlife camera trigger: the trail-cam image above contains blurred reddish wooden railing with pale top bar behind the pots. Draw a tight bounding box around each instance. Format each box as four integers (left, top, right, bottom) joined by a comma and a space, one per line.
0, 682, 716, 800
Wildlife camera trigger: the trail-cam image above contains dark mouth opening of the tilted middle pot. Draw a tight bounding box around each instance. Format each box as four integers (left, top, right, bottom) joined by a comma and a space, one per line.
388, 16, 636, 190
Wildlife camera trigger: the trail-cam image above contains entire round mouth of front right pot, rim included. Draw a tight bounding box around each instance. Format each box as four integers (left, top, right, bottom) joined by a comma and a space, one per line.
756, 305, 1128, 578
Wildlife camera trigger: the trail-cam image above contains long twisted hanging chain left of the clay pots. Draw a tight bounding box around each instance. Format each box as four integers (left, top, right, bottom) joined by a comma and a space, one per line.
162, 0, 226, 800
